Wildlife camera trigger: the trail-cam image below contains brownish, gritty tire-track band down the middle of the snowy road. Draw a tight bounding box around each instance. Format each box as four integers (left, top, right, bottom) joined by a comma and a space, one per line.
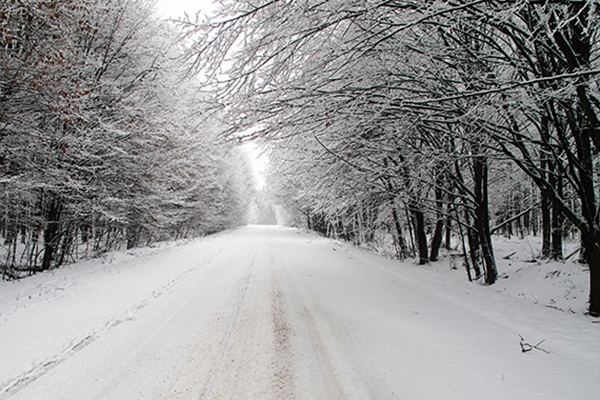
197, 236, 297, 400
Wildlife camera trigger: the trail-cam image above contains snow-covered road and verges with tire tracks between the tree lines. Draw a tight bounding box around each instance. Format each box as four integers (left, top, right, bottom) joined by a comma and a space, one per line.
0, 226, 600, 400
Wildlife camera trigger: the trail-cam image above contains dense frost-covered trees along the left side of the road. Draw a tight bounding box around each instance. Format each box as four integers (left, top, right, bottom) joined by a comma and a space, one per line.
0, 0, 253, 278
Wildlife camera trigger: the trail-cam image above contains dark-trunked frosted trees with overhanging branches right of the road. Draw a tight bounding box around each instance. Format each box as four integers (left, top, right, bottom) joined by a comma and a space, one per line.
183, 0, 600, 316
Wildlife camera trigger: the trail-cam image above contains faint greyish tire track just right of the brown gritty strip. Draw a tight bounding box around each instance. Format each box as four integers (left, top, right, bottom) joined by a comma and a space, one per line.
278, 241, 388, 400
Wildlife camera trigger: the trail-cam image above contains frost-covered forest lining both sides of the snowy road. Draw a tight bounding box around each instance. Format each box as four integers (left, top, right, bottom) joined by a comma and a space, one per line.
0, 0, 600, 316
